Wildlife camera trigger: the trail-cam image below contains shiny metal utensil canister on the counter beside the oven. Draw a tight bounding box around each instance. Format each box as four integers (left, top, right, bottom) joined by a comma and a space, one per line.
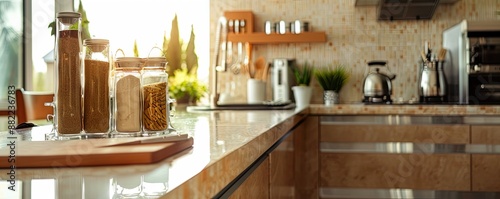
418, 60, 448, 103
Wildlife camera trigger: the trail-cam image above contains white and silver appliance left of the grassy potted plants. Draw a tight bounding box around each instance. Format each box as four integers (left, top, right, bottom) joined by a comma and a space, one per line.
271, 58, 296, 102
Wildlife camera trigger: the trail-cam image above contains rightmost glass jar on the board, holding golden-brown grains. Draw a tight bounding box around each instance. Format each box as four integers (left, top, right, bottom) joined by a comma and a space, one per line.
141, 57, 169, 136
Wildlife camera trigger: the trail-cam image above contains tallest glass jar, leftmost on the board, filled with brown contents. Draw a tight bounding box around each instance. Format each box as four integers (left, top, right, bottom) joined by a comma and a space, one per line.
54, 12, 82, 138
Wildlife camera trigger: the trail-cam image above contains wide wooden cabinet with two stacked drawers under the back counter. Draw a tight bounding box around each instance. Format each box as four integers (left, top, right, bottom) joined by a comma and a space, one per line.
319, 116, 471, 194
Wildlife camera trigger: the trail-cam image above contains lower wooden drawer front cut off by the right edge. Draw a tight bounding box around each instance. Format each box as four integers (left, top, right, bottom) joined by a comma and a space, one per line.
472, 154, 500, 192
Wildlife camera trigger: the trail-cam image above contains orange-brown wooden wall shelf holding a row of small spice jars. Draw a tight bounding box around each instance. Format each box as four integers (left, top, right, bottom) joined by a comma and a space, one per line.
228, 32, 326, 44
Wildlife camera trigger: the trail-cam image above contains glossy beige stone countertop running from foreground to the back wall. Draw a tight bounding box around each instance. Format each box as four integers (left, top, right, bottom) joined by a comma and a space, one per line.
0, 104, 500, 198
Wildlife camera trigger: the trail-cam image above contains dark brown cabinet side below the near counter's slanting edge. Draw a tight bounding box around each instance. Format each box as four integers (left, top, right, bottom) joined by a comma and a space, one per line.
226, 113, 319, 198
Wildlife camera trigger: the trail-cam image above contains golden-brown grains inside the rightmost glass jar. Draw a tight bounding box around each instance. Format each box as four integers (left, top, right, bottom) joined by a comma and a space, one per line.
142, 82, 168, 131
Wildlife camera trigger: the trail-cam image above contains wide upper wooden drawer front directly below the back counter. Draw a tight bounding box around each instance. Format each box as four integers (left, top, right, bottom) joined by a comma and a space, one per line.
320, 124, 468, 144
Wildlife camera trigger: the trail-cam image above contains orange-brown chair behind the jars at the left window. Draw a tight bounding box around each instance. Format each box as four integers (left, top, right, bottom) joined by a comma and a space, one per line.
16, 88, 54, 124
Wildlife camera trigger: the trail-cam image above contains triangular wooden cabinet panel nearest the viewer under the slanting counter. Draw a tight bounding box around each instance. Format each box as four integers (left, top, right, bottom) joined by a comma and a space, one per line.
229, 158, 269, 198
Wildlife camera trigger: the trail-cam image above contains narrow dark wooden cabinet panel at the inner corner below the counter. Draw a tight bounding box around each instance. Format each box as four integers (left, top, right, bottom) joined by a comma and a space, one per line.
294, 116, 319, 199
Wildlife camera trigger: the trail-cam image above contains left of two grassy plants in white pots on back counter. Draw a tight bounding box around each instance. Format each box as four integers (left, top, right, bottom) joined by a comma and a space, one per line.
292, 62, 314, 107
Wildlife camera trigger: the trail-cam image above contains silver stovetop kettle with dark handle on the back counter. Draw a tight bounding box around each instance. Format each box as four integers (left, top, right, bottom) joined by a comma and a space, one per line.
363, 61, 396, 103
